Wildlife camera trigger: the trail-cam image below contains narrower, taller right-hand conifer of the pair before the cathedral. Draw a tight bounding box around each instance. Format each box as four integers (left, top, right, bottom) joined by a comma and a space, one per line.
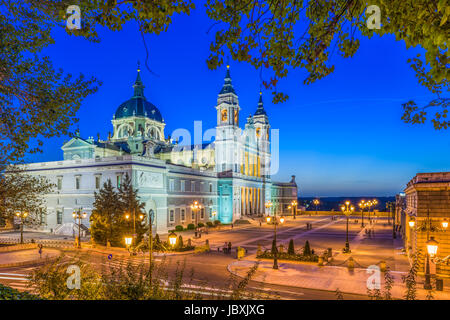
119, 174, 147, 244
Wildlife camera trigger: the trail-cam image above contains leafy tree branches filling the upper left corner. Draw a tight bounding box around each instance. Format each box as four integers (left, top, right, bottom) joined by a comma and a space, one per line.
0, 0, 194, 172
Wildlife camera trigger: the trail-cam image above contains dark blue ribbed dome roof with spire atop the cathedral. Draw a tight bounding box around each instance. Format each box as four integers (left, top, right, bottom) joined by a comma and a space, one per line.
114, 69, 163, 122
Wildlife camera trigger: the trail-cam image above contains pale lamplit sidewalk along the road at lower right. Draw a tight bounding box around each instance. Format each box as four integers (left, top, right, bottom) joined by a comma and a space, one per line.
228, 259, 450, 300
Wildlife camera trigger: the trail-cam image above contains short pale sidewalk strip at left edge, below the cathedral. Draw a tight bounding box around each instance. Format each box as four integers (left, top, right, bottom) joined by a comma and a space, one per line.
0, 248, 61, 268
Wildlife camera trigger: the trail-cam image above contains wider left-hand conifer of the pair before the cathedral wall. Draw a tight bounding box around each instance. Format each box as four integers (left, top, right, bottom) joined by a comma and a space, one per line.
90, 179, 124, 246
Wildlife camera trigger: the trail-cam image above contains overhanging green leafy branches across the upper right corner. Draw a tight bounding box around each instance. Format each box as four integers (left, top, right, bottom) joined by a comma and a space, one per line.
207, 0, 450, 129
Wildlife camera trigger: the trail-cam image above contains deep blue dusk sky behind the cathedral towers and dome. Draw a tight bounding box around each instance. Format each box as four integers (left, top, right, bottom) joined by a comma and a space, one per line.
27, 6, 450, 196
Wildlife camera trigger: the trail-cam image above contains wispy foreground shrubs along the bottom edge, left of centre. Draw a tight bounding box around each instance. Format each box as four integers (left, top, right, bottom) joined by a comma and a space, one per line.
29, 252, 273, 300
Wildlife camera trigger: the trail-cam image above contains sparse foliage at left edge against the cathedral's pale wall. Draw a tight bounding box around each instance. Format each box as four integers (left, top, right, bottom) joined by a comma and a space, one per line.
0, 167, 55, 227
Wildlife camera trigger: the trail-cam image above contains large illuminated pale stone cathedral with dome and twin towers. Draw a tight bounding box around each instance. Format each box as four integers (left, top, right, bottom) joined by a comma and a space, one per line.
22, 66, 298, 235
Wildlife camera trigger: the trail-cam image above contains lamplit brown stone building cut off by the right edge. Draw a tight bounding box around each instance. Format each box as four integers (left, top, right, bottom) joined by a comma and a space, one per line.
400, 172, 450, 276
